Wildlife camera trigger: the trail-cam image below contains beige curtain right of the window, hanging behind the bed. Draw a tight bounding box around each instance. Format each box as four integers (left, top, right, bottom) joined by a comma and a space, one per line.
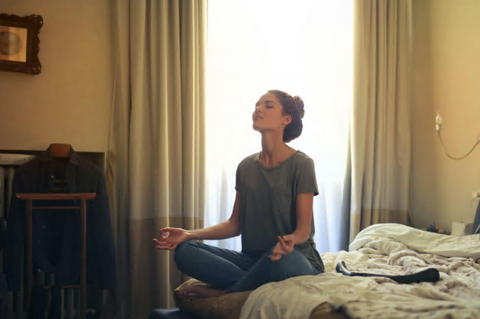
350, 0, 411, 240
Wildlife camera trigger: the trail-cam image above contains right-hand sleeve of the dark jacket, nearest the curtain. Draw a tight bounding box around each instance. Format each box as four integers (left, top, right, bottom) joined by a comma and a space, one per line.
87, 174, 116, 289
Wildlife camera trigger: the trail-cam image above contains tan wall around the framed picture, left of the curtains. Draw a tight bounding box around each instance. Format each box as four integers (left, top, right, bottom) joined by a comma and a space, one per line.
0, 0, 112, 152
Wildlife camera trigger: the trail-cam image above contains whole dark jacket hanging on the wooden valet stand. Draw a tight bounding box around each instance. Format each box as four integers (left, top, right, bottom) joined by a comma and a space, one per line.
5, 148, 115, 291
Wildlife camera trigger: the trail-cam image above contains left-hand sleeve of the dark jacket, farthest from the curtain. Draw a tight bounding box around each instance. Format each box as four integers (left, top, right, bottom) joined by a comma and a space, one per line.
5, 174, 26, 291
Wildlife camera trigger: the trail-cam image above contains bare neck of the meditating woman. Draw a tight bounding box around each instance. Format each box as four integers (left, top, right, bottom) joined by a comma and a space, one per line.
260, 133, 295, 167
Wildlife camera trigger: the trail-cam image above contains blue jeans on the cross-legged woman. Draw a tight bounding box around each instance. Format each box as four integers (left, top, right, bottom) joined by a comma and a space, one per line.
174, 241, 320, 293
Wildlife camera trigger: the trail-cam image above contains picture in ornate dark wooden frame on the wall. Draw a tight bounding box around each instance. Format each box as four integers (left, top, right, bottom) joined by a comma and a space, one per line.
0, 13, 43, 74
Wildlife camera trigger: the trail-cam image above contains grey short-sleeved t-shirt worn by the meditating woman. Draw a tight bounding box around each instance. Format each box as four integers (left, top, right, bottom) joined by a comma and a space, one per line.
235, 151, 324, 271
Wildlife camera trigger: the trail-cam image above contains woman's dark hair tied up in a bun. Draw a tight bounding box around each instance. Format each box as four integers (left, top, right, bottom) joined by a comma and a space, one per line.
268, 90, 305, 143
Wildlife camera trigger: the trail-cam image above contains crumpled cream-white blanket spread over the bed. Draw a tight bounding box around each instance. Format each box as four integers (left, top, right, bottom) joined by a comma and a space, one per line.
240, 224, 480, 319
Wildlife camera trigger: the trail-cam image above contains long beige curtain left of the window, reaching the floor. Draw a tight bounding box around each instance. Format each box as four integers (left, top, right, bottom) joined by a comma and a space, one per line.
107, 0, 206, 318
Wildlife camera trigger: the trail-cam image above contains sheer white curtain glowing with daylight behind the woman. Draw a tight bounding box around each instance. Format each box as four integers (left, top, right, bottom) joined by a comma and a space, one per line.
205, 0, 353, 252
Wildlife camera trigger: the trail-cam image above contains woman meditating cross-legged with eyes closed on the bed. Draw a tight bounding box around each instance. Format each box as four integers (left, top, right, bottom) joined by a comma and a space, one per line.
153, 90, 324, 299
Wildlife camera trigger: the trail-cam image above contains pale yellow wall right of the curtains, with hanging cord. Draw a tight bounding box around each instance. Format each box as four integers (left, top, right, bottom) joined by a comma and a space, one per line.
411, 0, 480, 230
